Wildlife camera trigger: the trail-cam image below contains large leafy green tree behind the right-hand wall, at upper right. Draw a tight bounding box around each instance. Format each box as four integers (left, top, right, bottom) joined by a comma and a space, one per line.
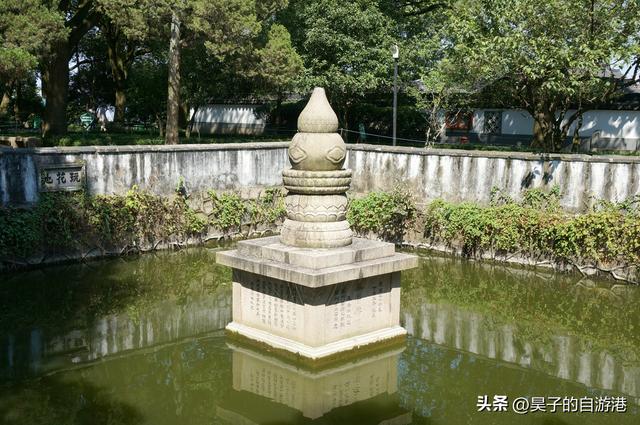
425, 0, 640, 151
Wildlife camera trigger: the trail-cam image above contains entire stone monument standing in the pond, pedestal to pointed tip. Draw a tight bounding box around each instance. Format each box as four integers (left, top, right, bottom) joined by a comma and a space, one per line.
217, 88, 417, 359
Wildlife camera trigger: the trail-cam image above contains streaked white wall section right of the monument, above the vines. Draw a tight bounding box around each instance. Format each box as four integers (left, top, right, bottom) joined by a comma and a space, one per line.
347, 145, 640, 211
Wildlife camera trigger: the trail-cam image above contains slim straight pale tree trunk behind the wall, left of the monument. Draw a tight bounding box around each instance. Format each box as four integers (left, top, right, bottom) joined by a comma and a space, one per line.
165, 12, 180, 145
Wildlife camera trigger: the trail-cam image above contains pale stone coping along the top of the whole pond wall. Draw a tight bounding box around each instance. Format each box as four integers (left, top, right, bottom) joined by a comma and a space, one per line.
0, 142, 640, 164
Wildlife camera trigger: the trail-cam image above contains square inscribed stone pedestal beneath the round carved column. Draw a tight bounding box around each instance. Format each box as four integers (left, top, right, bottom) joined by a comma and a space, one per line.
217, 237, 417, 360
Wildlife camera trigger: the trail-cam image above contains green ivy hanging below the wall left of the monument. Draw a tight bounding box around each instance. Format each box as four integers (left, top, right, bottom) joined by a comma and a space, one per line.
0, 184, 285, 263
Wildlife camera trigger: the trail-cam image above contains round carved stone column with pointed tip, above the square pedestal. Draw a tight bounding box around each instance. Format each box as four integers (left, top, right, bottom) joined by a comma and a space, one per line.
280, 87, 353, 248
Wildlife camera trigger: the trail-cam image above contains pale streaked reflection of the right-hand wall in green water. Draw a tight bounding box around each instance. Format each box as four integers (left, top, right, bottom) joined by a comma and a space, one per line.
404, 303, 640, 404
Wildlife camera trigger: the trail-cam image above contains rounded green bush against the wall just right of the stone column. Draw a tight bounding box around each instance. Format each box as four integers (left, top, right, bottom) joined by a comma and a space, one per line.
347, 188, 418, 242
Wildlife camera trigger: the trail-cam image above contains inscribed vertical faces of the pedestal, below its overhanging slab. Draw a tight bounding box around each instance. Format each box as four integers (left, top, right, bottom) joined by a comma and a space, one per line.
233, 271, 400, 347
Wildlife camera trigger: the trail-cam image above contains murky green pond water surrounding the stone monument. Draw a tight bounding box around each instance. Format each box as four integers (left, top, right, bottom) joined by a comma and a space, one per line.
0, 248, 640, 425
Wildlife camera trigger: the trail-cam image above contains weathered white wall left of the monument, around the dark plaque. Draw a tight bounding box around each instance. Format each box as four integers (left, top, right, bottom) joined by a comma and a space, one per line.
0, 143, 288, 205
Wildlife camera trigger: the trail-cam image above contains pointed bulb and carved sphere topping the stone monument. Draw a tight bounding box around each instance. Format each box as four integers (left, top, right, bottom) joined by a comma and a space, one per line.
289, 87, 347, 171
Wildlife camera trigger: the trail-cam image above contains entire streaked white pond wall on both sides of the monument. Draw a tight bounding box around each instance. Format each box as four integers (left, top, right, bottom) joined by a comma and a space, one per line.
0, 143, 640, 211
